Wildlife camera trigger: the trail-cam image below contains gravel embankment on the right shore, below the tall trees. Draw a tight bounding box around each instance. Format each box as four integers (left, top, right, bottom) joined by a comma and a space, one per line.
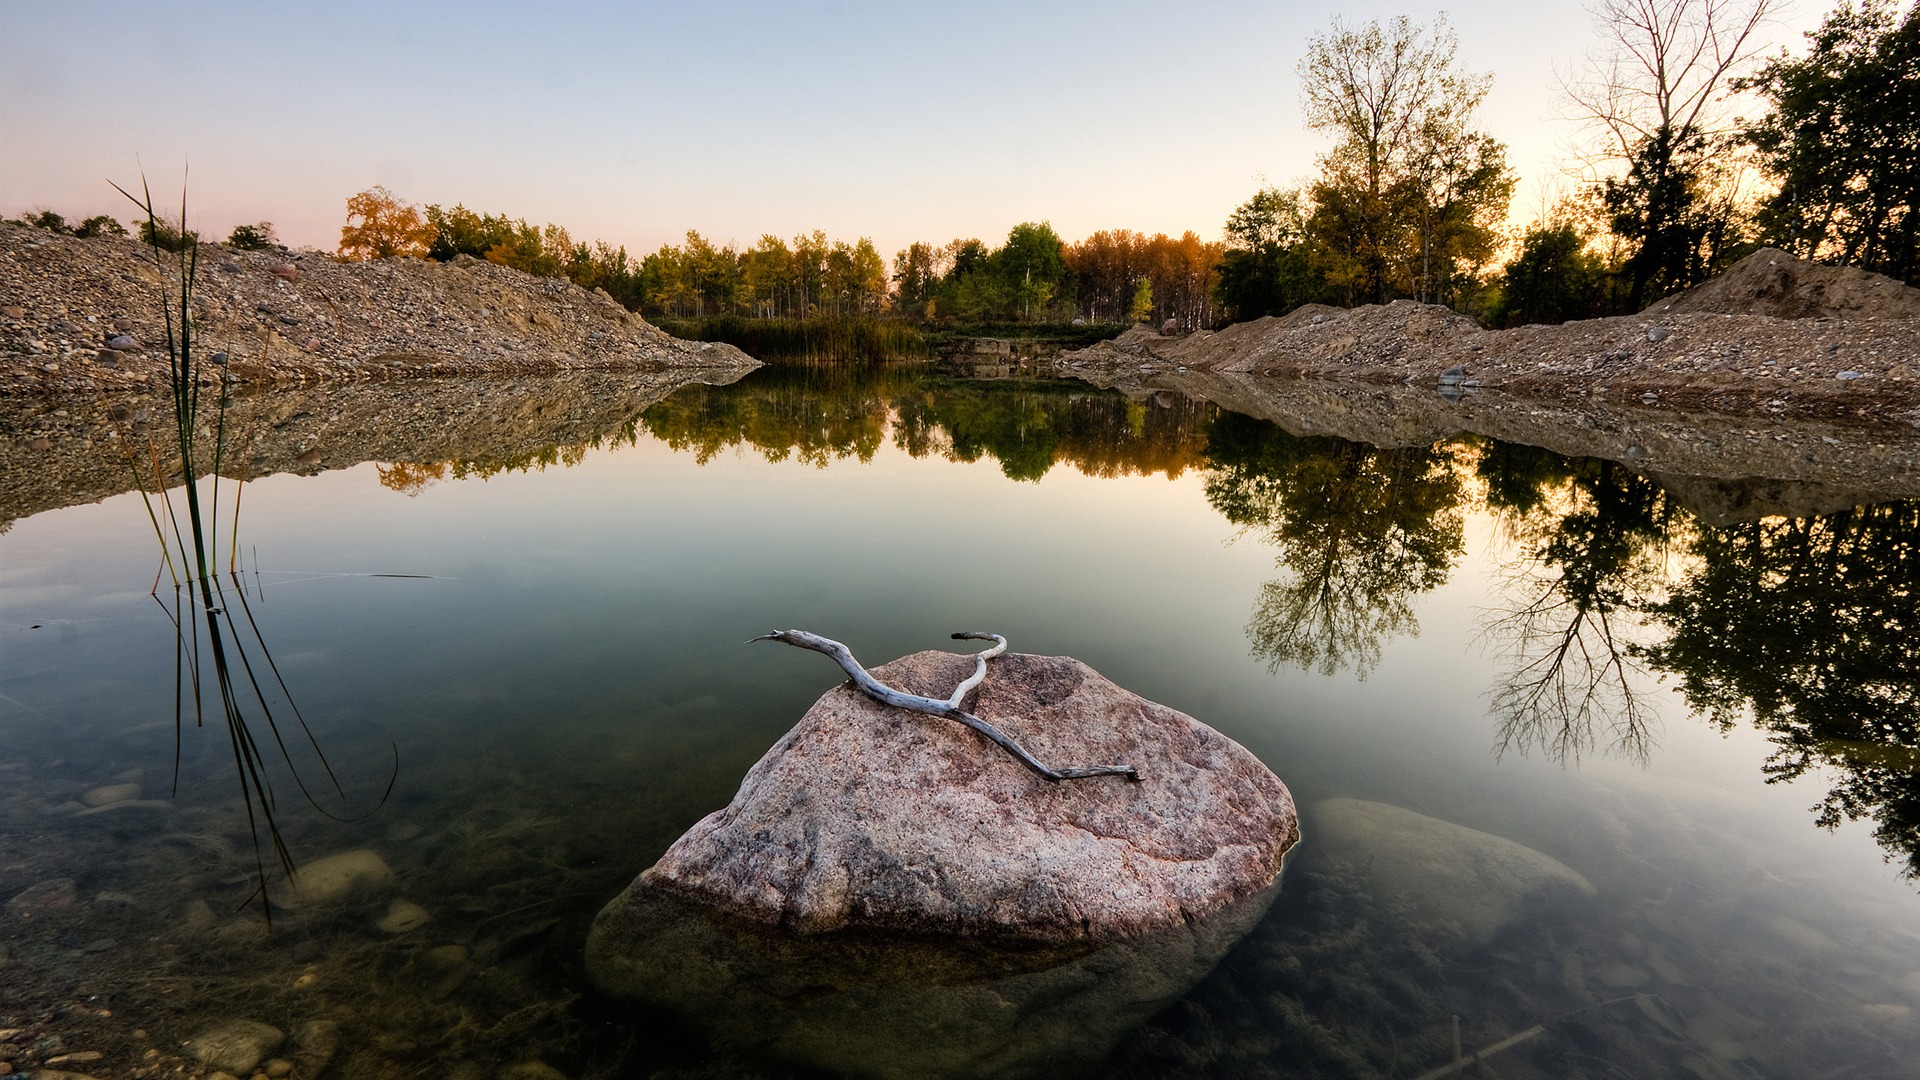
1060, 250, 1920, 427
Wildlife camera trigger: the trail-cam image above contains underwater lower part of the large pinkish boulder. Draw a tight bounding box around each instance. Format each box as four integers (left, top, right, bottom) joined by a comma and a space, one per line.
589, 864, 1279, 1080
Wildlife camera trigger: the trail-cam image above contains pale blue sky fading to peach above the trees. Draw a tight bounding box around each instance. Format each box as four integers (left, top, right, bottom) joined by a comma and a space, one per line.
0, 0, 1824, 256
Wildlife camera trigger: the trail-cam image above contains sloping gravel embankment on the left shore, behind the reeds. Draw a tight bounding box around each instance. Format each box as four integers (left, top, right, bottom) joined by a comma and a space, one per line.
0, 223, 758, 394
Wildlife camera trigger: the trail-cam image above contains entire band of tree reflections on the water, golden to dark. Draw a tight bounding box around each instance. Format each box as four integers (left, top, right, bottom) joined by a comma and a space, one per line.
357, 367, 1920, 876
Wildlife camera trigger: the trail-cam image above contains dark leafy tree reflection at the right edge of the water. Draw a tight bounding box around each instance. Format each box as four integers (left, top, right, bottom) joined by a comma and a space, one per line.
1647, 502, 1920, 878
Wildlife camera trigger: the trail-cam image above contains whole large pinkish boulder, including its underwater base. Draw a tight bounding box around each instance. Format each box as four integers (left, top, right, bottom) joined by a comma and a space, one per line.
588, 653, 1300, 1078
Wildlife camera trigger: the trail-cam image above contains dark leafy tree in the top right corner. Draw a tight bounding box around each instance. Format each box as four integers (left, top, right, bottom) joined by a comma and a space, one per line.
1741, 0, 1920, 281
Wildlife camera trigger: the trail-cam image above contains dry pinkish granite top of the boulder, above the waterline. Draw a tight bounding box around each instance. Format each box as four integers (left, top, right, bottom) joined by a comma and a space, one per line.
599, 651, 1300, 942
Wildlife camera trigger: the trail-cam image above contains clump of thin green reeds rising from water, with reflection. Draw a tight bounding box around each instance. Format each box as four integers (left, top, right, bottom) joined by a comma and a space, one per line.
109, 179, 397, 920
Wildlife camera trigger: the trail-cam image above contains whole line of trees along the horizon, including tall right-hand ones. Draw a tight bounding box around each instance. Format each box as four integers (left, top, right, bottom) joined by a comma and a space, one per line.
21, 0, 1920, 331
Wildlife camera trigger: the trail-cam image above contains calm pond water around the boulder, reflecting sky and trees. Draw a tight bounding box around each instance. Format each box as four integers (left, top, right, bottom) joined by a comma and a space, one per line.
0, 369, 1920, 1078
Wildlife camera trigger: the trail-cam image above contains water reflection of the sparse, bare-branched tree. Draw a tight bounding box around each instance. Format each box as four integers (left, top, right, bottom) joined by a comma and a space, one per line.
1476, 442, 1684, 761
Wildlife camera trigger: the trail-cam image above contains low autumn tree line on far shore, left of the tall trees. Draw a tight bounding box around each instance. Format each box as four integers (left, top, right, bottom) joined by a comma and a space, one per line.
340, 186, 1225, 331
